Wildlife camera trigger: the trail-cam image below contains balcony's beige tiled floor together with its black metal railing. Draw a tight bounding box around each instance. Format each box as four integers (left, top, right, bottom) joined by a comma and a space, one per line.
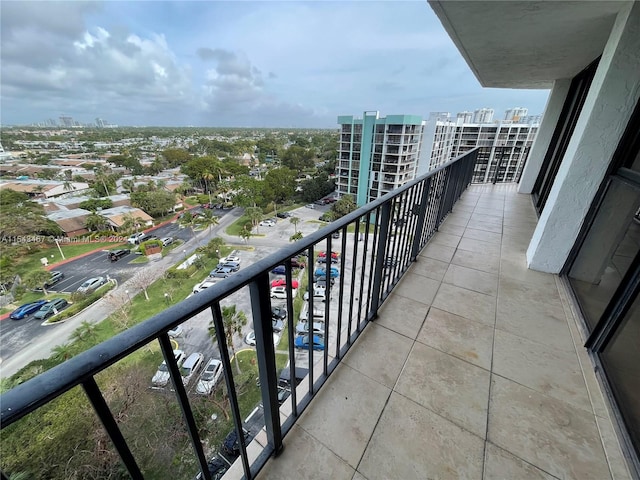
0, 150, 626, 480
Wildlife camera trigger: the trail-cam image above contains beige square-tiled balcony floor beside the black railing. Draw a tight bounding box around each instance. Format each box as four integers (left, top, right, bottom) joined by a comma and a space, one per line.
254, 185, 630, 480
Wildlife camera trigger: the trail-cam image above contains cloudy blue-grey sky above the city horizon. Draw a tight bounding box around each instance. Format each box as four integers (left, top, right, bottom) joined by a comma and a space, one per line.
0, 0, 548, 128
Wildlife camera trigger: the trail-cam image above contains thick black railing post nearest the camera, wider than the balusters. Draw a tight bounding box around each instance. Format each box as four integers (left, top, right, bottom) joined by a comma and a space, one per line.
249, 272, 282, 456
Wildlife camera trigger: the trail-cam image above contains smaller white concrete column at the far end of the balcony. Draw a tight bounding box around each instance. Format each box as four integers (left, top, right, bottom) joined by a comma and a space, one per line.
518, 78, 571, 193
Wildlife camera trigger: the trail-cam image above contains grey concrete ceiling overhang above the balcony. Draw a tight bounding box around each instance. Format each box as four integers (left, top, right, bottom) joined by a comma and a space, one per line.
429, 0, 626, 89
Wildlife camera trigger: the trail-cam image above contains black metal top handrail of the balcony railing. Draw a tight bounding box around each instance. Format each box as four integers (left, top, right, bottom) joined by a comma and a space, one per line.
0, 148, 478, 428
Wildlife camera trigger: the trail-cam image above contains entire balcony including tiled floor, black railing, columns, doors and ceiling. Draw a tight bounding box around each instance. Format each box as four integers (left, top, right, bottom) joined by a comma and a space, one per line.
0, 0, 640, 480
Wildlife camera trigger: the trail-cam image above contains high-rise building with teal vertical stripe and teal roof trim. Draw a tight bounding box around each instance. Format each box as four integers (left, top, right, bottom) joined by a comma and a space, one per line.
336, 112, 425, 205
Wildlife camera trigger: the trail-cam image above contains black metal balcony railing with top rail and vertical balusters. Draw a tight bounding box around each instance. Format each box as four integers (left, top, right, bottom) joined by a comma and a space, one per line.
0, 150, 477, 480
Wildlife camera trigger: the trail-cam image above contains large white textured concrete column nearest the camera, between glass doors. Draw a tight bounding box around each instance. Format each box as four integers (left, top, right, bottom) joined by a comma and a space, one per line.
527, 3, 640, 273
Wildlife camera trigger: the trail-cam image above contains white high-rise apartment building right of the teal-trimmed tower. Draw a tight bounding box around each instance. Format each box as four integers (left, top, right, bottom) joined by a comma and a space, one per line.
419, 108, 539, 183
